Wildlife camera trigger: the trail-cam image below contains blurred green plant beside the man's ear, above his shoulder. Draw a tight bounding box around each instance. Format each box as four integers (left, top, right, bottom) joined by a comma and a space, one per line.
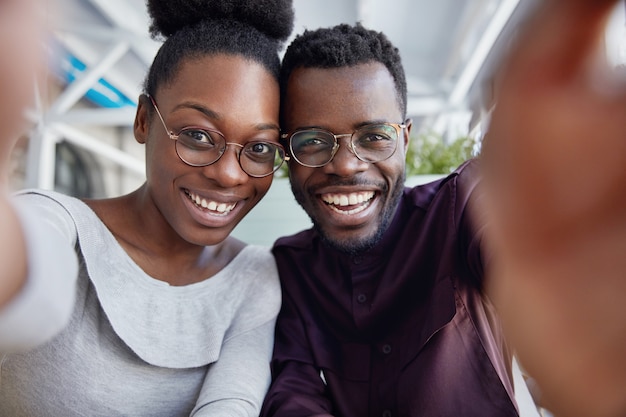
406, 132, 477, 176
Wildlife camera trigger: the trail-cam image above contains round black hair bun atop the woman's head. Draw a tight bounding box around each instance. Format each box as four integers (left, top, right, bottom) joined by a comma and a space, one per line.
146, 0, 294, 41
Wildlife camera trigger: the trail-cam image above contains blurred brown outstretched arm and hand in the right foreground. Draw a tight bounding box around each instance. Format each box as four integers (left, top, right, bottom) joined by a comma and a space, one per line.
482, 0, 626, 417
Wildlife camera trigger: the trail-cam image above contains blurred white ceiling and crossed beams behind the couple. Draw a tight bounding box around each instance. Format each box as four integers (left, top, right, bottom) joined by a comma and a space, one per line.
27, 0, 626, 188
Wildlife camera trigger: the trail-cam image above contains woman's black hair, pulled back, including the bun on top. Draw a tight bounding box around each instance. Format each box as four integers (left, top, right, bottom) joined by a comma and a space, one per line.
144, 0, 294, 95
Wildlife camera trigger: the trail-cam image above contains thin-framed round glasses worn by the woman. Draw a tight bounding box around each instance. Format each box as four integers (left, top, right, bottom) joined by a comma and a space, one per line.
147, 95, 285, 178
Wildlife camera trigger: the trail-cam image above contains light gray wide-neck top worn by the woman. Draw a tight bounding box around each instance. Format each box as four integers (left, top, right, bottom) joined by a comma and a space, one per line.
0, 192, 280, 417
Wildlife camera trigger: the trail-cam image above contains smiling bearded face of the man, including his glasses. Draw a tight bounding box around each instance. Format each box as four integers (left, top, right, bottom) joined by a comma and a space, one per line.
284, 62, 404, 254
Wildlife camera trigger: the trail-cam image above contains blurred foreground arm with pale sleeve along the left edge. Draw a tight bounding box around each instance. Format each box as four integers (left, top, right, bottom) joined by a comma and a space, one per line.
0, 0, 77, 355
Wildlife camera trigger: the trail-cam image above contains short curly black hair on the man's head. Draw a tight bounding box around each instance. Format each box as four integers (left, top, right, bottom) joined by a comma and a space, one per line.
279, 23, 407, 118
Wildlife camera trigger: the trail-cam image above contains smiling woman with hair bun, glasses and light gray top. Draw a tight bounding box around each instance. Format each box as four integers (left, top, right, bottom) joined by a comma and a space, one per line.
0, 0, 293, 417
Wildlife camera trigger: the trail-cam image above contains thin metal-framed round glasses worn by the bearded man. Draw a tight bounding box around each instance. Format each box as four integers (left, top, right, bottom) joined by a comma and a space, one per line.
281, 123, 406, 168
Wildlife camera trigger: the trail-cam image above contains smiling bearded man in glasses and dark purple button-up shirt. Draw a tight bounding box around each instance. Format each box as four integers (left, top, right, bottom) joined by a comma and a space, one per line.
262, 25, 518, 417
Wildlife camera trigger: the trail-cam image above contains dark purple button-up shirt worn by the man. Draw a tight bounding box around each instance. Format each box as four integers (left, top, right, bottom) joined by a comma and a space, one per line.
261, 159, 518, 417
